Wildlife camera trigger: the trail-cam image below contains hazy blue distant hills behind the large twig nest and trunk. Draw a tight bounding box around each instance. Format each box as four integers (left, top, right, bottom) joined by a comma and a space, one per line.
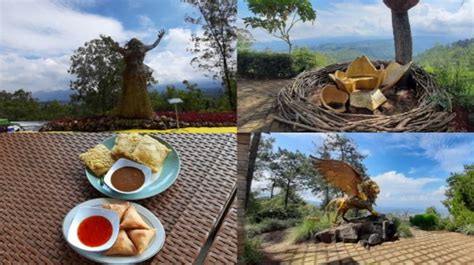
253, 36, 456, 62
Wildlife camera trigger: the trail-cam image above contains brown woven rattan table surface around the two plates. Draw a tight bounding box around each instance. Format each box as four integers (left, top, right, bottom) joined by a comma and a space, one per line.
0, 133, 237, 264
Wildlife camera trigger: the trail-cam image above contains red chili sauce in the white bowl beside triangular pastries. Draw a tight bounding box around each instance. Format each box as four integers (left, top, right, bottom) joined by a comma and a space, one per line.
77, 215, 112, 247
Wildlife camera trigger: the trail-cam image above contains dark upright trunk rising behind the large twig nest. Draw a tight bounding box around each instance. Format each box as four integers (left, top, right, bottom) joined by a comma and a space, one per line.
392, 10, 413, 65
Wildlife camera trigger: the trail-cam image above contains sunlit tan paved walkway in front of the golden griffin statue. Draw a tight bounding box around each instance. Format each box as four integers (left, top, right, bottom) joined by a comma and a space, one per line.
262, 230, 474, 264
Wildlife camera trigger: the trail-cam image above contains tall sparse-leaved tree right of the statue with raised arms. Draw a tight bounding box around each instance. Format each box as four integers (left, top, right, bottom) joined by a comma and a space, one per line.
183, 0, 237, 110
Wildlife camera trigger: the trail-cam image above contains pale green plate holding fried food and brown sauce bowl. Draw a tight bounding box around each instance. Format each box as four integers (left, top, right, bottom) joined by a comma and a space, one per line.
86, 136, 181, 201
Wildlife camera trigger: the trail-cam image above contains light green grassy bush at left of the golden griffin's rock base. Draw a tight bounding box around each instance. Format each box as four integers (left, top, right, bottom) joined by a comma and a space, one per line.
287, 215, 331, 244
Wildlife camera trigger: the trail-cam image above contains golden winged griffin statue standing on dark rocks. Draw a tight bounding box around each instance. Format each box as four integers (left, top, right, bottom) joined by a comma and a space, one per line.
312, 157, 380, 223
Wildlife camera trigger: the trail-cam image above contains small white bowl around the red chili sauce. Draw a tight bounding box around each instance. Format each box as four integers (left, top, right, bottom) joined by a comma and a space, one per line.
67, 207, 120, 252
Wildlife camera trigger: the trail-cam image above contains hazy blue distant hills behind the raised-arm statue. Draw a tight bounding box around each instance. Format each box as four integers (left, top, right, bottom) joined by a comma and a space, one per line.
33, 80, 224, 103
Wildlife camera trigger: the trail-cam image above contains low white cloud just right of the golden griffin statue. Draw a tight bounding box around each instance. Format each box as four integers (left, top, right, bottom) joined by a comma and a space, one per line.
372, 171, 445, 209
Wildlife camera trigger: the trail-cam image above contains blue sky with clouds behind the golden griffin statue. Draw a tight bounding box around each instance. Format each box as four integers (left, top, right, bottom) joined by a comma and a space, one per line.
254, 133, 474, 210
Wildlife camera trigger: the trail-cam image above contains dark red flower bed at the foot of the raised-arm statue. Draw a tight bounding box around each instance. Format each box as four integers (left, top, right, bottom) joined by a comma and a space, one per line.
40, 112, 236, 132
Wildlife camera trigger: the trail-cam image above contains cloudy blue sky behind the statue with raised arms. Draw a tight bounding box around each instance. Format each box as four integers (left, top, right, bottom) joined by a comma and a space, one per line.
0, 0, 218, 91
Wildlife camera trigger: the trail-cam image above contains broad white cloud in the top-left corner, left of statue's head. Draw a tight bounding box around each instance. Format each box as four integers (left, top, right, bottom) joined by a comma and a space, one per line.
0, 0, 136, 55
